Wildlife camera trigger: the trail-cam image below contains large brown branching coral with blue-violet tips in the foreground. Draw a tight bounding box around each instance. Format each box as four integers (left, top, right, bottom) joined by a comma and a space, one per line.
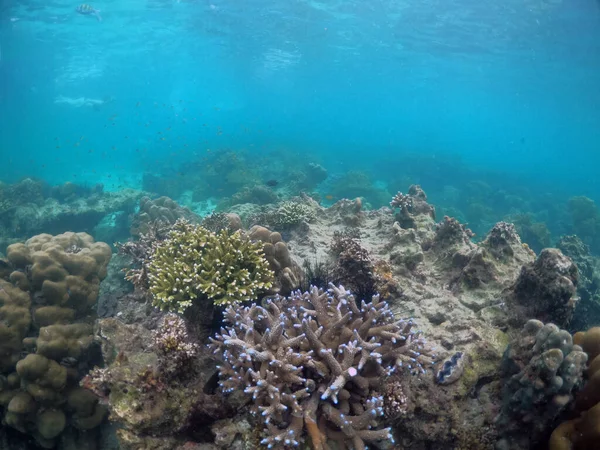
210, 285, 431, 450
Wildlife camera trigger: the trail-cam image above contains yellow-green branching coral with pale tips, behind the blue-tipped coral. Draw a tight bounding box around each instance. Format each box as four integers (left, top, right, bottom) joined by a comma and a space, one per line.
148, 221, 274, 312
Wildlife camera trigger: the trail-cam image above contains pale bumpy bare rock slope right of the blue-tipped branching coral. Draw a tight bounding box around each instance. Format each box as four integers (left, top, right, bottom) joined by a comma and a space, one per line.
280, 188, 535, 449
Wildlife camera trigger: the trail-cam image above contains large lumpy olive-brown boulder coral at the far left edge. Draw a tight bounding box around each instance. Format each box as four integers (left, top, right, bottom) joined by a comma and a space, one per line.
0, 232, 111, 448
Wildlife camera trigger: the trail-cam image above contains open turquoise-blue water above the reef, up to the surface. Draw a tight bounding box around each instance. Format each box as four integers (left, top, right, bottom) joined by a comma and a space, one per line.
0, 0, 600, 234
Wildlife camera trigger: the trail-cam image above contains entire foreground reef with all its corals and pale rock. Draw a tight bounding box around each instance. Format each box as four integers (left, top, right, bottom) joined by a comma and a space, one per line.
0, 184, 600, 450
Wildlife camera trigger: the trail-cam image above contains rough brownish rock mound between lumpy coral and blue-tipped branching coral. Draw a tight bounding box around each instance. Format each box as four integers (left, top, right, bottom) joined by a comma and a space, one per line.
82, 314, 240, 450
